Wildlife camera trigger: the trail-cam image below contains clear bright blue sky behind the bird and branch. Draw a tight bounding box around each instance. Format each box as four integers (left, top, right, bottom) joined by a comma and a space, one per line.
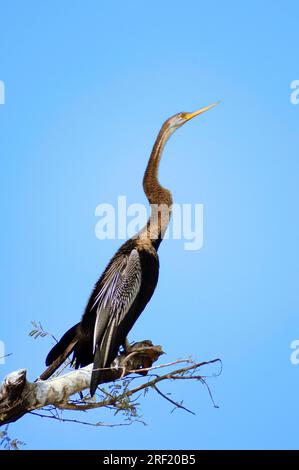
0, 0, 299, 449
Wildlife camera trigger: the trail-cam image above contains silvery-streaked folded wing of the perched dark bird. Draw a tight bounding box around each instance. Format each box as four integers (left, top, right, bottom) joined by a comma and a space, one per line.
93, 249, 141, 366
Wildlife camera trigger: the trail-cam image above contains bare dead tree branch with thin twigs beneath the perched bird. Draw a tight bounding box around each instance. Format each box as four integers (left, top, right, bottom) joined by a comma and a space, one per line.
0, 340, 219, 426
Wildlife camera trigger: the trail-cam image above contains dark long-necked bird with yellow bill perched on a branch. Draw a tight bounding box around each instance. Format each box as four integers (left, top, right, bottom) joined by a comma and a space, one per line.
46, 103, 218, 396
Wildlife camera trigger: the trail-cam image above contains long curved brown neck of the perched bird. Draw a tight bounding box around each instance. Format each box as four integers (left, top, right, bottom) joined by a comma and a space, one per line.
139, 124, 173, 248
